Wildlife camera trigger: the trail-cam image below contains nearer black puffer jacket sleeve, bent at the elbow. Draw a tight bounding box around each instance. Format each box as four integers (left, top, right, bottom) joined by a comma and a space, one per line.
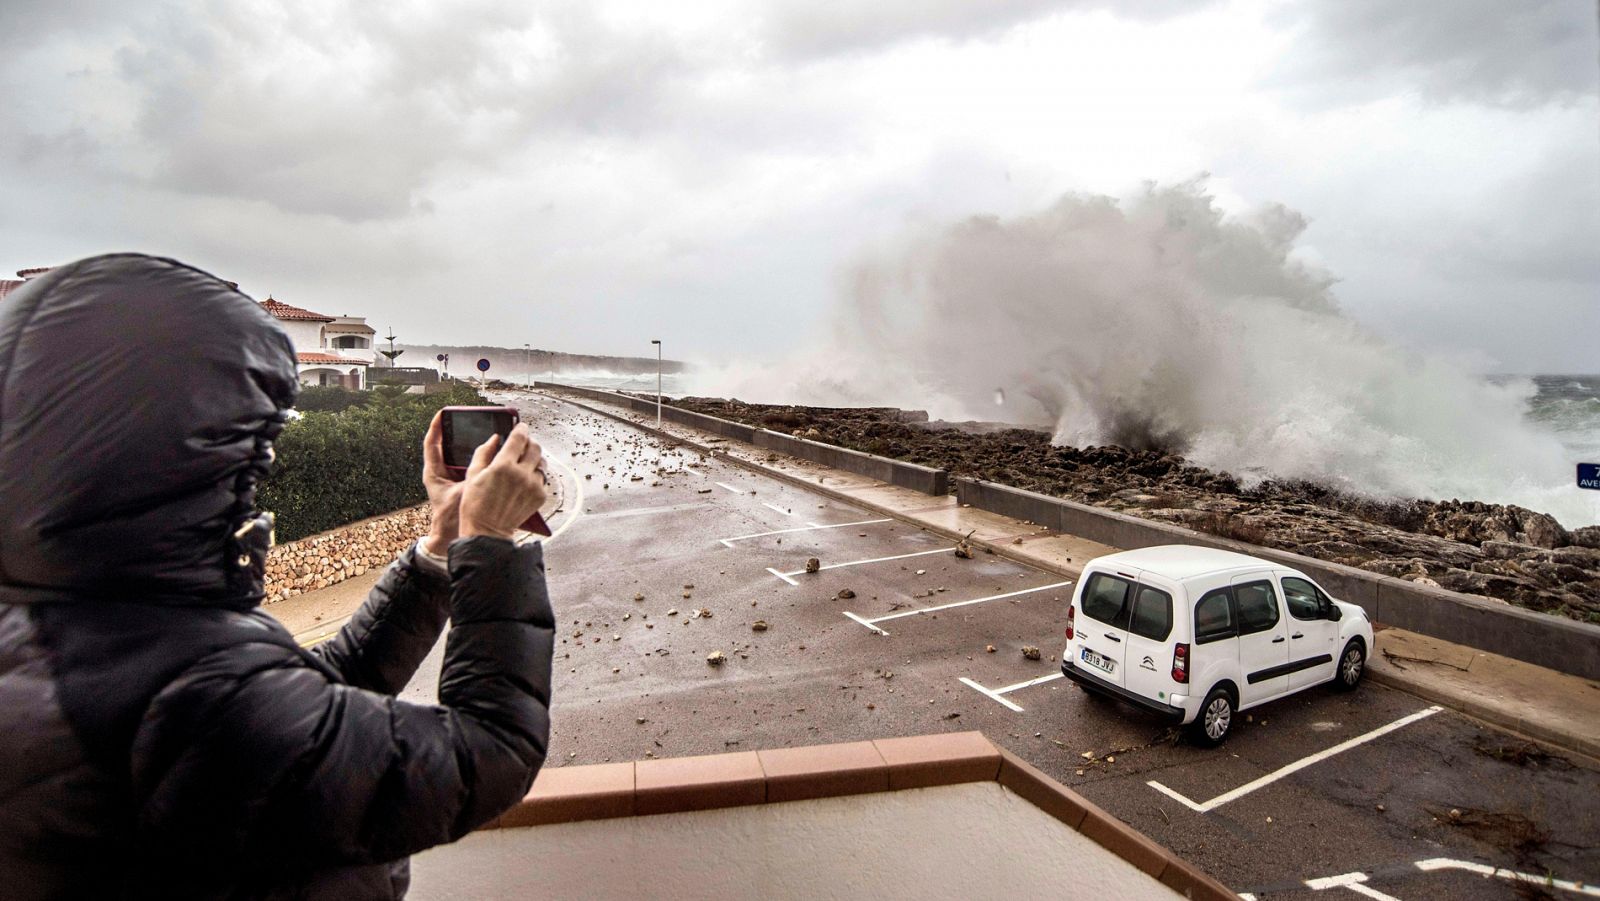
133, 536, 554, 879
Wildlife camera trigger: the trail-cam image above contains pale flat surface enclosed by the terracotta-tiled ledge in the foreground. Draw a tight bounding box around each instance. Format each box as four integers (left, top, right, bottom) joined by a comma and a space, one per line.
408, 783, 1178, 901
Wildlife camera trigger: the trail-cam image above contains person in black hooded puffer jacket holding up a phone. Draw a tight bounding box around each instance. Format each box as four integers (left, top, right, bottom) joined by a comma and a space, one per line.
0, 254, 554, 899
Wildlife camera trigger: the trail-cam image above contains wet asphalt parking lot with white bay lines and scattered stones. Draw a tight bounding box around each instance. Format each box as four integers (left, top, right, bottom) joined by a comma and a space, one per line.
406, 395, 1600, 899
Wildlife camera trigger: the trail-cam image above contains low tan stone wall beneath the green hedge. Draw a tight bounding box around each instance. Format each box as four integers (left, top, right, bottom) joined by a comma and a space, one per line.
266, 504, 429, 603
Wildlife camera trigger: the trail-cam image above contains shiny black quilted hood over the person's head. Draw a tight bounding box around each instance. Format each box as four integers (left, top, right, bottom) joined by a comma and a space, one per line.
0, 254, 299, 608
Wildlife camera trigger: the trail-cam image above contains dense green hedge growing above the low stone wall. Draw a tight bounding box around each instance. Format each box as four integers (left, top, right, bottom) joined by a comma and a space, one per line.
256, 382, 488, 541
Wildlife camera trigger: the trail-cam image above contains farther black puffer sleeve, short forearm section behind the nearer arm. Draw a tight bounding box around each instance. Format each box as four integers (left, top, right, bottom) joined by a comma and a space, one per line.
312, 544, 450, 695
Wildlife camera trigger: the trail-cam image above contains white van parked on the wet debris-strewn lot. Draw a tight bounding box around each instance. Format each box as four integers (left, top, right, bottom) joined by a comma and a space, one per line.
1061, 544, 1373, 746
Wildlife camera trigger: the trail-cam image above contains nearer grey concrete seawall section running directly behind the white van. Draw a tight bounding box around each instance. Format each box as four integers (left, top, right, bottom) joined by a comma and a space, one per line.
955, 479, 1600, 679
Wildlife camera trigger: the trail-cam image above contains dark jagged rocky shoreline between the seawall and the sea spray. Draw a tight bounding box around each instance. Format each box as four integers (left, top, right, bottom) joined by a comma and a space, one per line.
674, 397, 1600, 623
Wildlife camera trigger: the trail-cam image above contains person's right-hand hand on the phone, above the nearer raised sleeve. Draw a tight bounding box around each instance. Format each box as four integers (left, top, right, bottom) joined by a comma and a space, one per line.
461, 422, 549, 538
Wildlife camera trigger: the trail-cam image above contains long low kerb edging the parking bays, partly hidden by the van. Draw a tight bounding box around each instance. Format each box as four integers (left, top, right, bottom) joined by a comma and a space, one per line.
538, 390, 1600, 762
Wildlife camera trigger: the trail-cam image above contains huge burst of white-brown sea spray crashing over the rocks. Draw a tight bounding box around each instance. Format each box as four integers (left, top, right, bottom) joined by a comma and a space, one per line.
694, 181, 1600, 527
